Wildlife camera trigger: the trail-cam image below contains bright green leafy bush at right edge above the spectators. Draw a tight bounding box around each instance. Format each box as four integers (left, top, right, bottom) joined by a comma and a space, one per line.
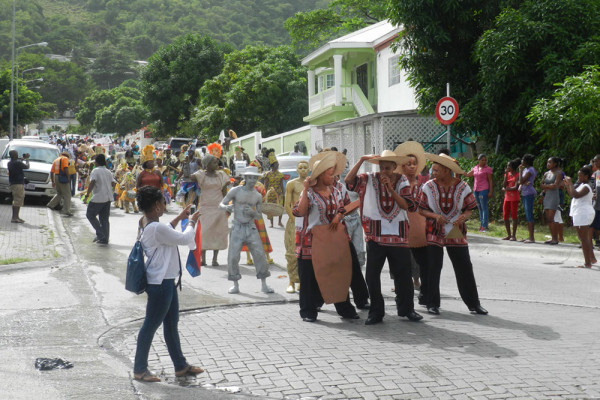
527, 65, 600, 171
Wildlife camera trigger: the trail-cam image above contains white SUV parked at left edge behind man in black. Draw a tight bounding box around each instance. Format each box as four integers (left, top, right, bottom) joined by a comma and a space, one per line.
0, 140, 59, 197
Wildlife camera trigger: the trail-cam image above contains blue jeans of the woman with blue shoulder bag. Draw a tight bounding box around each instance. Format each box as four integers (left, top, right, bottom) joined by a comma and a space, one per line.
133, 279, 187, 374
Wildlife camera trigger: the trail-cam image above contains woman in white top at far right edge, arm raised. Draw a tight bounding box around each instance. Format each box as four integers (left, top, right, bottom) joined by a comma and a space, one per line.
564, 167, 597, 268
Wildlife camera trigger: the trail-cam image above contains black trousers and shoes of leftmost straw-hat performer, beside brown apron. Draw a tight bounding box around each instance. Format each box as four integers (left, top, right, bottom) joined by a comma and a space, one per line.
298, 258, 356, 318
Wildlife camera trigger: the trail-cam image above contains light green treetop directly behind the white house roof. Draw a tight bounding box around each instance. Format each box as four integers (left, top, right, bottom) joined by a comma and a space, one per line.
284, 0, 386, 50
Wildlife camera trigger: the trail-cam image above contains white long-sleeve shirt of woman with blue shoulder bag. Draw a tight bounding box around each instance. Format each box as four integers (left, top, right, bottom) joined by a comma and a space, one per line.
140, 222, 196, 285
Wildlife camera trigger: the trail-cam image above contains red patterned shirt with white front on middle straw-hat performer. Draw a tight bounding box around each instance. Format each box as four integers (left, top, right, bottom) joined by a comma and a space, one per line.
348, 172, 417, 247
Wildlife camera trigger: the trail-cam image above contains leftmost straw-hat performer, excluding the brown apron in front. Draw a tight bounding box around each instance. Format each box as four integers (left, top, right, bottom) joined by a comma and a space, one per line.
292, 151, 360, 322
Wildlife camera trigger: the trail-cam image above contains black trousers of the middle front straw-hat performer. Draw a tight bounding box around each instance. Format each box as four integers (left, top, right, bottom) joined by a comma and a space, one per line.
366, 241, 415, 318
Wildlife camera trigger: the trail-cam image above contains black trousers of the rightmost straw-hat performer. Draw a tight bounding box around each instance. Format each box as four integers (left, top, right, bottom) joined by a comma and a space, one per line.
421, 245, 479, 309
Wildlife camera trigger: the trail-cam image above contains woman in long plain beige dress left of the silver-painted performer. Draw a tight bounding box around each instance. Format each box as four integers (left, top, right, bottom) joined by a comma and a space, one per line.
190, 154, 229, 267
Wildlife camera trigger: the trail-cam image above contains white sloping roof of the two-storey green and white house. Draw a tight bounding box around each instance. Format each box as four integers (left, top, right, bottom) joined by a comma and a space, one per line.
302, 20, 400, 65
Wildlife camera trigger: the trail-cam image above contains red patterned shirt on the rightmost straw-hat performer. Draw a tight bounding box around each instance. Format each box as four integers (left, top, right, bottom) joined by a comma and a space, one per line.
419, 179, 477, 247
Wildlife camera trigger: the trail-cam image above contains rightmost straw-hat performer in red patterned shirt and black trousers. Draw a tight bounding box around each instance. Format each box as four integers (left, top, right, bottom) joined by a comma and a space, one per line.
419, 153, 488, 315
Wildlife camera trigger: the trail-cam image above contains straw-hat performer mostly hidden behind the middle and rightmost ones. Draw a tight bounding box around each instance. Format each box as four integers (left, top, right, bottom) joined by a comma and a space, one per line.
394, 141, 427, 298
